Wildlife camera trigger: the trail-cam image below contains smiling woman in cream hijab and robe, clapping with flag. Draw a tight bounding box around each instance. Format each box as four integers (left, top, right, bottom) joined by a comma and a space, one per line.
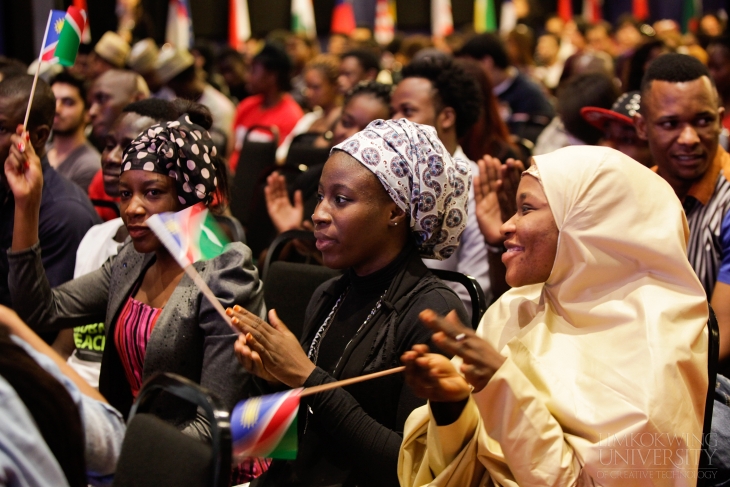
398, 147, 708, 486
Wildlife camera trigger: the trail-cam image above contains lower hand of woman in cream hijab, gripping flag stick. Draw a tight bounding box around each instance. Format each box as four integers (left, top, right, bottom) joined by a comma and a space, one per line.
401, 345, 471, 402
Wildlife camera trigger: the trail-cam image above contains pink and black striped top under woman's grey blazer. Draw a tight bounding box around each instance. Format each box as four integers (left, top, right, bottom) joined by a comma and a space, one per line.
114, 293, 162, 397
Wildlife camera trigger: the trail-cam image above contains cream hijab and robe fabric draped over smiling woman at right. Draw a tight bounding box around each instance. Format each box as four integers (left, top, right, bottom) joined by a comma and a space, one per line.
401, 146, 708, 486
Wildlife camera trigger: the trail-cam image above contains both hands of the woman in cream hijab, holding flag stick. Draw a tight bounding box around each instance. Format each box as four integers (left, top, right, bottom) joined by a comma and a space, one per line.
401, 310, 505, 402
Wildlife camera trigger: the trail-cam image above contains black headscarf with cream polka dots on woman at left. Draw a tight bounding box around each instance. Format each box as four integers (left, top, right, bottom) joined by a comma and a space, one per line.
122, 115, 218, 207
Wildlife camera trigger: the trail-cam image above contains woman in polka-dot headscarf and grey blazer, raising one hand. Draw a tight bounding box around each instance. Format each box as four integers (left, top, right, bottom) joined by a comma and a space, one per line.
5, 115, 264, 442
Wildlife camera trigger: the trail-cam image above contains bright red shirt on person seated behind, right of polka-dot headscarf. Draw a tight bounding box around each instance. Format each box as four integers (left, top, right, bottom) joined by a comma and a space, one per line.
230, 93, 304, 171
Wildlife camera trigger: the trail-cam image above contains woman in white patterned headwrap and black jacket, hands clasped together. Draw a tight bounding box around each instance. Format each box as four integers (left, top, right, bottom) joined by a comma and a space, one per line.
233, 120, 470, 486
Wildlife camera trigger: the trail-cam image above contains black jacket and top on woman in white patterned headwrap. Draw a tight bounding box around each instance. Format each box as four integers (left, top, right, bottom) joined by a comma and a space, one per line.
252, 245, 468, 487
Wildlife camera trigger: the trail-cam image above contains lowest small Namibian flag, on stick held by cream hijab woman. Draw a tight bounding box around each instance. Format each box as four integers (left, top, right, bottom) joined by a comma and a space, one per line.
231, 388, 303, 460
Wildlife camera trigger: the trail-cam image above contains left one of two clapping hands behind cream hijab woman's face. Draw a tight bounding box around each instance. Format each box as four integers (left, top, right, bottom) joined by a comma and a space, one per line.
474, 156, 506, 246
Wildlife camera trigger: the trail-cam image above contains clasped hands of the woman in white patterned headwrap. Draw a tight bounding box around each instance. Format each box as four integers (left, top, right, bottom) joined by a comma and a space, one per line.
226, 305, 315, 387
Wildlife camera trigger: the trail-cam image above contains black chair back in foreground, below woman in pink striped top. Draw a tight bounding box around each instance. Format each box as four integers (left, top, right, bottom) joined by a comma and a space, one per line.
113, 373, 231, 487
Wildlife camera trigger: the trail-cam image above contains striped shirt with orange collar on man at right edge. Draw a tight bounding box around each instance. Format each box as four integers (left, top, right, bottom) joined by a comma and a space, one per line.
682, 147, 730, 298
